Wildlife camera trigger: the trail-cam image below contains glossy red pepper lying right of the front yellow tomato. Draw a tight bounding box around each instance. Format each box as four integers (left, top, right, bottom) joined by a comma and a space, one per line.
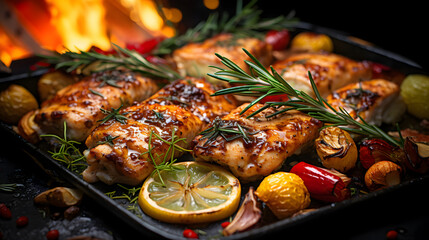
290, 162, 350, 202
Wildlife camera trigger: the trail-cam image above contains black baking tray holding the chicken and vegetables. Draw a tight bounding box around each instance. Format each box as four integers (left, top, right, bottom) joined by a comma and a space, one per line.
0, 22, 428, 239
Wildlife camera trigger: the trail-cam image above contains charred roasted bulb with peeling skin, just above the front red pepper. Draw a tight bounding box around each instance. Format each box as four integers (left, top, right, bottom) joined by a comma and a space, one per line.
315, 127, 358, 173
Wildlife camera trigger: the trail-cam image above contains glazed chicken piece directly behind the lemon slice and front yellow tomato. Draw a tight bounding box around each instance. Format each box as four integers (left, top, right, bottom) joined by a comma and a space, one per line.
193, 103, 323, 181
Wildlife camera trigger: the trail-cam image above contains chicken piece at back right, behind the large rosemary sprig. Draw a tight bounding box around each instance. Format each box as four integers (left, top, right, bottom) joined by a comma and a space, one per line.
273, 52, 372, 97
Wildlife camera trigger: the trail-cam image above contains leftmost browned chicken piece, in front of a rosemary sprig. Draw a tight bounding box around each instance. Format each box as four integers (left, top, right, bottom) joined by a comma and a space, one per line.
29, 71, 158, 142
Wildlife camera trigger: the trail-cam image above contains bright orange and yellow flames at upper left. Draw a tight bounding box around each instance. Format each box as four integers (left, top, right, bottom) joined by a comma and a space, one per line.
0, 0, 182, 65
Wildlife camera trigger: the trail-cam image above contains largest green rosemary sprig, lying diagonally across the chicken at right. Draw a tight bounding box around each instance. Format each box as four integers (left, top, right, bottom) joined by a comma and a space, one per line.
208, 49, 403, 147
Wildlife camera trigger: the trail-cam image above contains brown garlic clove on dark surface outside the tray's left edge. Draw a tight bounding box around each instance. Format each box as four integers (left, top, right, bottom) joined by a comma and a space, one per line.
34, 187, 83, 207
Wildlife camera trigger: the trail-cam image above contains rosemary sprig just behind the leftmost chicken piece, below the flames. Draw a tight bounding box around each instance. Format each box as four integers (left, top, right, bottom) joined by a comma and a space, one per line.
39, 44, 181, 80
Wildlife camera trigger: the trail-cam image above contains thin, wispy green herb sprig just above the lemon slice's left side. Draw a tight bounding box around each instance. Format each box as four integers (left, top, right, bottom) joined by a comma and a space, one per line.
145, 128, 191, 187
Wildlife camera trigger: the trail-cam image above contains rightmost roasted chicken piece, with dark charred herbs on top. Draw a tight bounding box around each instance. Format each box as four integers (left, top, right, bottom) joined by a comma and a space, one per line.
327, 79, 406, 126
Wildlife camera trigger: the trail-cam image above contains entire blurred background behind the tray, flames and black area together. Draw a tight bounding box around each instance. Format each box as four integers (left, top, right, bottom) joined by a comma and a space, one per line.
0, 0, 429, 68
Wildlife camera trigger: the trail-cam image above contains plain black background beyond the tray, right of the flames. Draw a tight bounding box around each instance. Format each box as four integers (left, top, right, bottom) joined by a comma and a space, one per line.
173, 0, 429, 69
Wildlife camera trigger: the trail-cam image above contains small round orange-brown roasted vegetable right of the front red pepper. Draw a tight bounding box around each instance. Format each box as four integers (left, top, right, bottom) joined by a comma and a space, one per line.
365, 161, 402, 191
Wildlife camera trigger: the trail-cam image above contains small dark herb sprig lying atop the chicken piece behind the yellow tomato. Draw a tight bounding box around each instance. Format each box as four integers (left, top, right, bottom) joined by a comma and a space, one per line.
200, 117, 260, 146
